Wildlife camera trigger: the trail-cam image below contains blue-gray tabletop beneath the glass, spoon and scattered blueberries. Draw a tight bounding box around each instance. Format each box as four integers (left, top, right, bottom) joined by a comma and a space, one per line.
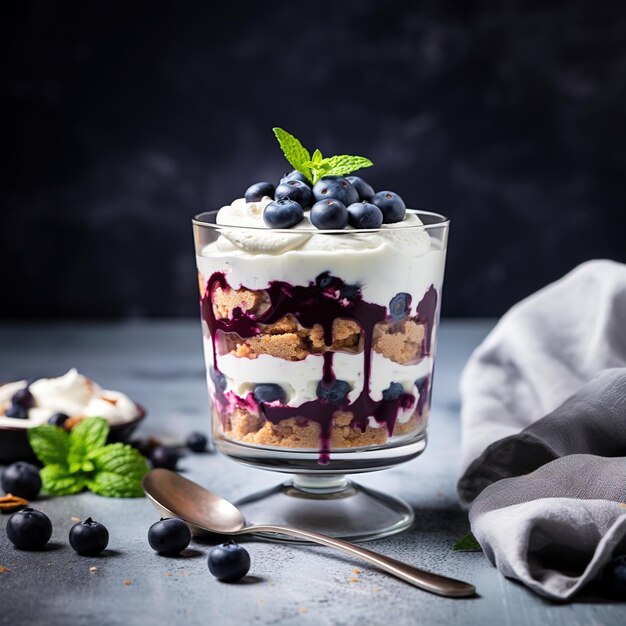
0, 321, 625, 626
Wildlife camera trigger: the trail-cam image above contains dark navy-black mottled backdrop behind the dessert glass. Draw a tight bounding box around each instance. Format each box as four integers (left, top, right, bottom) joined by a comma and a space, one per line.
0, 0, 626, 319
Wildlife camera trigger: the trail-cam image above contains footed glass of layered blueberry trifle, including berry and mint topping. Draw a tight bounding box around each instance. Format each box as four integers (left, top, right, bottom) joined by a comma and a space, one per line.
193, 129, 448, 540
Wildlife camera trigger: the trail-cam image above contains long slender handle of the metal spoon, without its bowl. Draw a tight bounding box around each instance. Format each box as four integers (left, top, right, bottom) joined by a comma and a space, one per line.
237, 525, 476, 598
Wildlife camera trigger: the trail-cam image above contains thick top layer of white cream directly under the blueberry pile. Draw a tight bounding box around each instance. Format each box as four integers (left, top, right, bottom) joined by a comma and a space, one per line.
197, 198, 446, 306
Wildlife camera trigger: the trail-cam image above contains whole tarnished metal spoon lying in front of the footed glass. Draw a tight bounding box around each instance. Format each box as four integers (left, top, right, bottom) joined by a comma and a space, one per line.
143, 469, 476, 598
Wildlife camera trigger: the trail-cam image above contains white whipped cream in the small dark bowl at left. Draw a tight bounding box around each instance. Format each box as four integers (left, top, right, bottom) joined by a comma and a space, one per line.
0, 369, 142, 428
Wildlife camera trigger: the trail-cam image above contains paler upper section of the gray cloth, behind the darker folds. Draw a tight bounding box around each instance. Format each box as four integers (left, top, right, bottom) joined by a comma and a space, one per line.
461, 261, 626, 478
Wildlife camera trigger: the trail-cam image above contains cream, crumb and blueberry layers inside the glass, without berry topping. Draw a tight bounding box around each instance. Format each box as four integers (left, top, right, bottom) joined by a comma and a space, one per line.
197, 203, 445, 462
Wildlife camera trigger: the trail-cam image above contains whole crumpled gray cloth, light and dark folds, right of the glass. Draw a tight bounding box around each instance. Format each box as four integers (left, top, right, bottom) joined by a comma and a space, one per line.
459, 261, 626, 600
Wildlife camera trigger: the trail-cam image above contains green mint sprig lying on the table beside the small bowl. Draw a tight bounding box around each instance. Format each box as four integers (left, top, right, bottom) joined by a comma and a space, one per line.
28, 417, 148, 498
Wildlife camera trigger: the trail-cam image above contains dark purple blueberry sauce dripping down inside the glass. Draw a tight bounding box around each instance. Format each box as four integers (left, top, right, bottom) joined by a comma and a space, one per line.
200, 272, 437, 464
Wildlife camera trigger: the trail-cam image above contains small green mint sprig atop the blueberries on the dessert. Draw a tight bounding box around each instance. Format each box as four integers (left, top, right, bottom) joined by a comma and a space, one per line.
272, 128, 374, 184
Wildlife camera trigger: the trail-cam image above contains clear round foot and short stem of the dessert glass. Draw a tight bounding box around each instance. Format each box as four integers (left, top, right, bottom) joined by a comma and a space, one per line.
236, 474, 415, 541
